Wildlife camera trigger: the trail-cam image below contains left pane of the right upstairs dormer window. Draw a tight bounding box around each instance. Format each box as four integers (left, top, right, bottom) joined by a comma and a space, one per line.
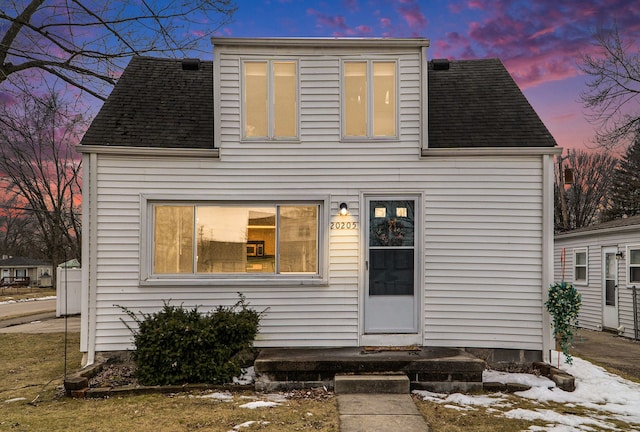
344, 62, 367, 136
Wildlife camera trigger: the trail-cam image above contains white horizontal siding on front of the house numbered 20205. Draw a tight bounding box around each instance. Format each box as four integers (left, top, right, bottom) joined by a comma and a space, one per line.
82, 42, 551, 352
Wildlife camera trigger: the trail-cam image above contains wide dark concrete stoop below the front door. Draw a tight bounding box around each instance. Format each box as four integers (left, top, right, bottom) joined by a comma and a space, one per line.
254, 347, 486, 393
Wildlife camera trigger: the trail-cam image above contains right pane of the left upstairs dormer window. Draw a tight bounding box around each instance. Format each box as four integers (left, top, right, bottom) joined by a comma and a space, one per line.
273, 62, 298, 137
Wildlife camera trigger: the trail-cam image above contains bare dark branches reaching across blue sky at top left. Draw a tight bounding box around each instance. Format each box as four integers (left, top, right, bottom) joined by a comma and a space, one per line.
0, 0, 236, 100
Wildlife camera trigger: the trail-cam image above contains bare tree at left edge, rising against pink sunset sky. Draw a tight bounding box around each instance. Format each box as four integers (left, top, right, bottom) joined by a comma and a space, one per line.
0, 90, 86, 274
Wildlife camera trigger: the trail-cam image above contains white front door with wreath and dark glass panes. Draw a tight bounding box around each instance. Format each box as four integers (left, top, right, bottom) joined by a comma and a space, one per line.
364, 197, 420, 336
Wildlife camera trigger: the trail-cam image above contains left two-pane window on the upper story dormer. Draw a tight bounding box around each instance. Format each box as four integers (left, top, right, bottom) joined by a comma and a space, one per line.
243, 60, 298, 139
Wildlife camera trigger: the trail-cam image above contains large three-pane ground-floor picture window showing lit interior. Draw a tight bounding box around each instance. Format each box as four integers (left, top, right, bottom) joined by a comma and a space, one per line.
152, 204, 320, 275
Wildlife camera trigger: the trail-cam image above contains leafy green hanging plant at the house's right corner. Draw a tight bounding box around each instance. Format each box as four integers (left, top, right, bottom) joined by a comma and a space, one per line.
545, 281, 582, 364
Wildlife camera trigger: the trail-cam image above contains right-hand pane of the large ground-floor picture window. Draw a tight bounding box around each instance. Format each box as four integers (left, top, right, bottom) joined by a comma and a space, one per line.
279, 206, 318, 273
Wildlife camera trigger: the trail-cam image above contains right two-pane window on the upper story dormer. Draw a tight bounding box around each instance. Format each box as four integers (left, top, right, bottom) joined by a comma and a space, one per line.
342, 60, 397, 138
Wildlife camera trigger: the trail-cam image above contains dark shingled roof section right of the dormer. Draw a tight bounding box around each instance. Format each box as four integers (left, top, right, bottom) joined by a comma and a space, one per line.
428, 59, 556, 148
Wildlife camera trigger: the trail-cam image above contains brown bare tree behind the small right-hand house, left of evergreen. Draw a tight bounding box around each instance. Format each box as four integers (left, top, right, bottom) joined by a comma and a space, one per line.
555, 150, 618, 231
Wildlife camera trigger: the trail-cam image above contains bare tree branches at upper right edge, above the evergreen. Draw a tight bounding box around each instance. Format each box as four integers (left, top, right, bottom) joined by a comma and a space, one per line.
580, 25, 640, 149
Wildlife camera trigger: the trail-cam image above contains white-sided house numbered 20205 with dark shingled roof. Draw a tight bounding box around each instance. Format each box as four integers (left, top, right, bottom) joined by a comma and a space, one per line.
78, 38, 560, 363
